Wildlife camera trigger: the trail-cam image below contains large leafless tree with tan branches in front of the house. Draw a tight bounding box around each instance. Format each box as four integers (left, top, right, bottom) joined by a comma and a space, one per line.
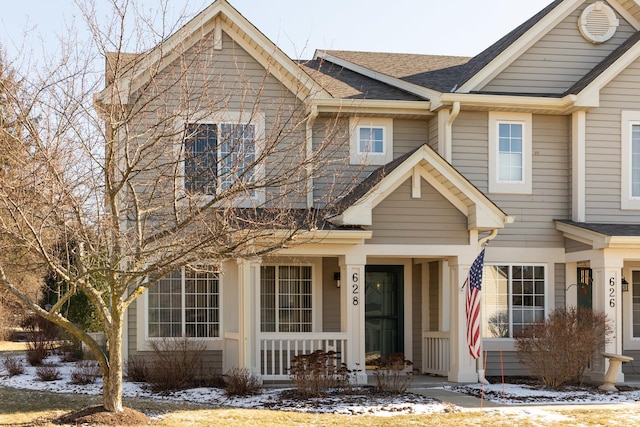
0, 0, 357, 411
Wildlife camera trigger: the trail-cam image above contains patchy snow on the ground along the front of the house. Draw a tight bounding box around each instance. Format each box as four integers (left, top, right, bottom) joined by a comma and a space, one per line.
0, 355, 640, 422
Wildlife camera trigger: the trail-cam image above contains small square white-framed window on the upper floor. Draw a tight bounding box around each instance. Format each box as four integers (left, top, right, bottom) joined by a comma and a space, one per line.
349, 117, 393, 165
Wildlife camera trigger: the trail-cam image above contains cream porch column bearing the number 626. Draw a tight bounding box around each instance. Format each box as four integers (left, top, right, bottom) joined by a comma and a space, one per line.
591, 254, 624, 382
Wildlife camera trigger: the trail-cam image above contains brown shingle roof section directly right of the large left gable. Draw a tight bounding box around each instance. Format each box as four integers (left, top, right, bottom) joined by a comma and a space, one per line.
299, 60, 423, 101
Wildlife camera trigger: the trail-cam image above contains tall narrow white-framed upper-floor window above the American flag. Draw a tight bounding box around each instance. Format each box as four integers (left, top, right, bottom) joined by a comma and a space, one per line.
489, 112, 533, 194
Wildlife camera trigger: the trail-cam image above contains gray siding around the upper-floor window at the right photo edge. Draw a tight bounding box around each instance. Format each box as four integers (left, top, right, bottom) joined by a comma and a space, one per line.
586, 60, 640, 223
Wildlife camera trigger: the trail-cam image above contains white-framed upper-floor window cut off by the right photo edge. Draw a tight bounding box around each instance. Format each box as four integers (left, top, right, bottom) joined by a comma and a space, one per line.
620, 111, 640, 209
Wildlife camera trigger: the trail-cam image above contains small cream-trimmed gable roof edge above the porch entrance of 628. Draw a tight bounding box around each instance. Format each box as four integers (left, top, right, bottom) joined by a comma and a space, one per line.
329, 144, 513, 231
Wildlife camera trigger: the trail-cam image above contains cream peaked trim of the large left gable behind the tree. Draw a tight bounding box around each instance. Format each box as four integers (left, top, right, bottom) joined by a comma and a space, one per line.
95, 0, 331, 104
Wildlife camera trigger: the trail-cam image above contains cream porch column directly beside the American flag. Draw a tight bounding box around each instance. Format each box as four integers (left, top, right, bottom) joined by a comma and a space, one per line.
448, 256, 482, 383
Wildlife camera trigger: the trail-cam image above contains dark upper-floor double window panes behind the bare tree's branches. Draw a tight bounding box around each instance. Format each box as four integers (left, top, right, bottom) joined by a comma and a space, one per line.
184, 123, 256, 197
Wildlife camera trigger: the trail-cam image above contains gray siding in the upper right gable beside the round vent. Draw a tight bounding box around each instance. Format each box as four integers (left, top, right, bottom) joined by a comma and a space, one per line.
482, 2, 635, 93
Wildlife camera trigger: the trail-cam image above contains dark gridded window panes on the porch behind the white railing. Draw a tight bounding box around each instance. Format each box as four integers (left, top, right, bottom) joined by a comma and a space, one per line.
260, 265, 313, 332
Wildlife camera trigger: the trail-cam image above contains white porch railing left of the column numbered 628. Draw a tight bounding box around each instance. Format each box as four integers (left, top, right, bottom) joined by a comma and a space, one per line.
258, 332, 347, 380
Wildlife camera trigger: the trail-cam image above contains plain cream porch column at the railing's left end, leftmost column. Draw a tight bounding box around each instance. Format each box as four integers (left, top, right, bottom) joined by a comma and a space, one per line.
238, 259, 260, 374
